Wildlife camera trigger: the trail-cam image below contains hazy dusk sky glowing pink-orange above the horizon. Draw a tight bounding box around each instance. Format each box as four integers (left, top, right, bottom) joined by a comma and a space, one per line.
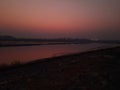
0, 0, 120, 39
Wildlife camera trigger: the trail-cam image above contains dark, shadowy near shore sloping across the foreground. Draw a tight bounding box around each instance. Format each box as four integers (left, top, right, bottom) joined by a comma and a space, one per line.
0, 47, 120, 90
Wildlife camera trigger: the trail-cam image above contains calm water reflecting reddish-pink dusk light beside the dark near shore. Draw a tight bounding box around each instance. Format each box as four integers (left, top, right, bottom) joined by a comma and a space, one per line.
0, 44, 116, 64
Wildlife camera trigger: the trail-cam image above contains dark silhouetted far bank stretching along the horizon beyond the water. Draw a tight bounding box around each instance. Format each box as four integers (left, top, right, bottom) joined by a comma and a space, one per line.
0, 36, 120, 47
